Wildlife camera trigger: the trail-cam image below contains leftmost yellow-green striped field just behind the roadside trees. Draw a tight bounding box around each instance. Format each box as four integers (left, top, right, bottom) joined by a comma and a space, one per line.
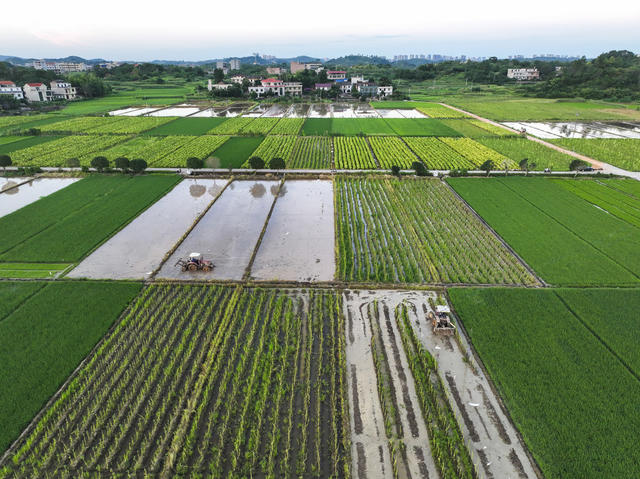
11, 135, 127, 166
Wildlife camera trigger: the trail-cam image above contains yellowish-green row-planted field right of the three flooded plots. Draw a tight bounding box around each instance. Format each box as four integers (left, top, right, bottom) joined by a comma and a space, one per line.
335, 178, 536, 284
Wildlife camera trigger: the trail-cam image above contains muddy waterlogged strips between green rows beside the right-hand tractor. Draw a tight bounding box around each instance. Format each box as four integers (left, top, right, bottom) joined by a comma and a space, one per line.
344, 290, 537, 479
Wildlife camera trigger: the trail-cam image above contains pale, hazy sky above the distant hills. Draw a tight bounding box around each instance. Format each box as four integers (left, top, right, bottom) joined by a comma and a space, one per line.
0, 0, 640, 61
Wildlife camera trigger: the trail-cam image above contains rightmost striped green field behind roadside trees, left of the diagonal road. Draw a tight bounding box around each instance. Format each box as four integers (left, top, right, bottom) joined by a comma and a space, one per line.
476, 137, 575, 171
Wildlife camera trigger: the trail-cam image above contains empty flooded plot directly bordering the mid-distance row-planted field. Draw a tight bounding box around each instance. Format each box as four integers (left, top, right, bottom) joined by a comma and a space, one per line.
251, 180, 335, 282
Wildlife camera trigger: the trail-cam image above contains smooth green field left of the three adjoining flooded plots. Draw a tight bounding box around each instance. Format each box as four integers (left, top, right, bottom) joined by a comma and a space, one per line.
0, 175, 179, 262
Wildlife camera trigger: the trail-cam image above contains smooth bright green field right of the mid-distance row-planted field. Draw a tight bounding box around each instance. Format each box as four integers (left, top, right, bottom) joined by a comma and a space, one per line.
447, 178, 640, 286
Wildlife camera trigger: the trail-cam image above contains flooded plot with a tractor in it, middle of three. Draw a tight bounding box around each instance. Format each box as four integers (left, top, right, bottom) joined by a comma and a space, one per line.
157, 181, 279, 280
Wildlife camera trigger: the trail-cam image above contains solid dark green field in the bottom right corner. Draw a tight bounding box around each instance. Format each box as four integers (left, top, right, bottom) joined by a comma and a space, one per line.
449, 289, 640, 479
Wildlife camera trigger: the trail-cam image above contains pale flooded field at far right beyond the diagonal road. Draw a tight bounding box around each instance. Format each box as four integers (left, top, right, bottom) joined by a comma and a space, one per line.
504, 121, 640, 139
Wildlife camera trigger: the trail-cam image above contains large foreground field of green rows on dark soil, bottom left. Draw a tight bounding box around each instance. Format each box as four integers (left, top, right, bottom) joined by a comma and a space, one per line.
0, 285, 351, 477
